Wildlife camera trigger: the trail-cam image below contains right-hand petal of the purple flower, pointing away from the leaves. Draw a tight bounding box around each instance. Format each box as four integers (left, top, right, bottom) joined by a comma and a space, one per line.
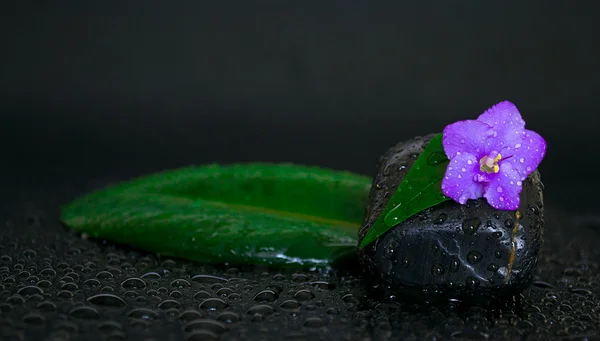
507, 130, 546, 180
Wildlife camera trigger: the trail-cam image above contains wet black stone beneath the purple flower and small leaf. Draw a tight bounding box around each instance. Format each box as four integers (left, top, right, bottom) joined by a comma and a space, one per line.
358, 134, 544, 296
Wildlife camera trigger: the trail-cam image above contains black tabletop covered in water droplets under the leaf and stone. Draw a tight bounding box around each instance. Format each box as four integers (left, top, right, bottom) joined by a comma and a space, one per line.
0, 174, 600, 340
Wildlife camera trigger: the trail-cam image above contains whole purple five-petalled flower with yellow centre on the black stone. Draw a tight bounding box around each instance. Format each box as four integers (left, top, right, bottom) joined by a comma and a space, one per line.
442, 101, 546, 210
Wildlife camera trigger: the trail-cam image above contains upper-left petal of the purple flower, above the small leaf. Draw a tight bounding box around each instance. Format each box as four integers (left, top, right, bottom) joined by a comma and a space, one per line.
442, 120, 494, 160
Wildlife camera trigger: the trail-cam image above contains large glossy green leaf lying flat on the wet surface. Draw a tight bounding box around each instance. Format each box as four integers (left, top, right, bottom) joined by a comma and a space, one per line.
61, 163, 371, 267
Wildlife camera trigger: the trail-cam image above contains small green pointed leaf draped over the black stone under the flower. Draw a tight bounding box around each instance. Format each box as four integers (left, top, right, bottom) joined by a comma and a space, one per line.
360, 134, 449, 248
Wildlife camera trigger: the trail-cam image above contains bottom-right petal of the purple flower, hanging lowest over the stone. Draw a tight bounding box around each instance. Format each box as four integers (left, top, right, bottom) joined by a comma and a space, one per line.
483, 162, 523, 211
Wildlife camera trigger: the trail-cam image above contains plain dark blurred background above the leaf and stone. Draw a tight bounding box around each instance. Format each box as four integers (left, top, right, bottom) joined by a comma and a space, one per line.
0, 0, 600, 212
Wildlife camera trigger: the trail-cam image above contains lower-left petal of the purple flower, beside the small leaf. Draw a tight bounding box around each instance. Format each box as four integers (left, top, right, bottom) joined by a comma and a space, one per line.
442, 153, 486, 204
